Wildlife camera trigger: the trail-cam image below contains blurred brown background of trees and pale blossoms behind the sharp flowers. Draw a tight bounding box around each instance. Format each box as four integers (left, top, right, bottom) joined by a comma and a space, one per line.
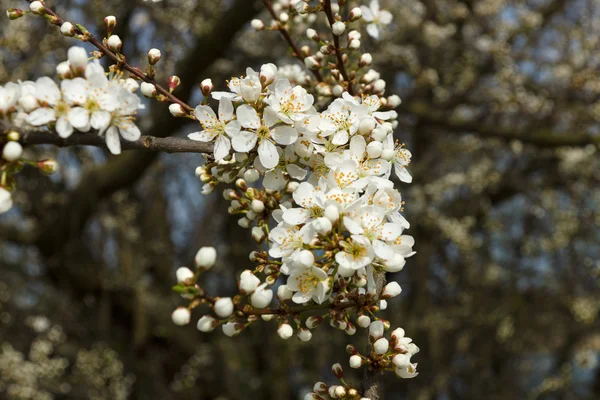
0, 0, 600, 400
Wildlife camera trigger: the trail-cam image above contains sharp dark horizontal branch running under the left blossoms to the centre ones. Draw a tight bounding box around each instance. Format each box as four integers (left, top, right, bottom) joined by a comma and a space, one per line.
19, 131, 213, 153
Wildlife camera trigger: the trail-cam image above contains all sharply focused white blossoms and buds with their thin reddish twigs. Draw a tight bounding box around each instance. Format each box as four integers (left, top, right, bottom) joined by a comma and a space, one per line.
0, 0, 418, 398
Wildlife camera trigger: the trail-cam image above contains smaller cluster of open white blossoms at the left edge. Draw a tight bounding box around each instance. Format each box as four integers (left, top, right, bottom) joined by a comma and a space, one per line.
0, 47, 144, 154
